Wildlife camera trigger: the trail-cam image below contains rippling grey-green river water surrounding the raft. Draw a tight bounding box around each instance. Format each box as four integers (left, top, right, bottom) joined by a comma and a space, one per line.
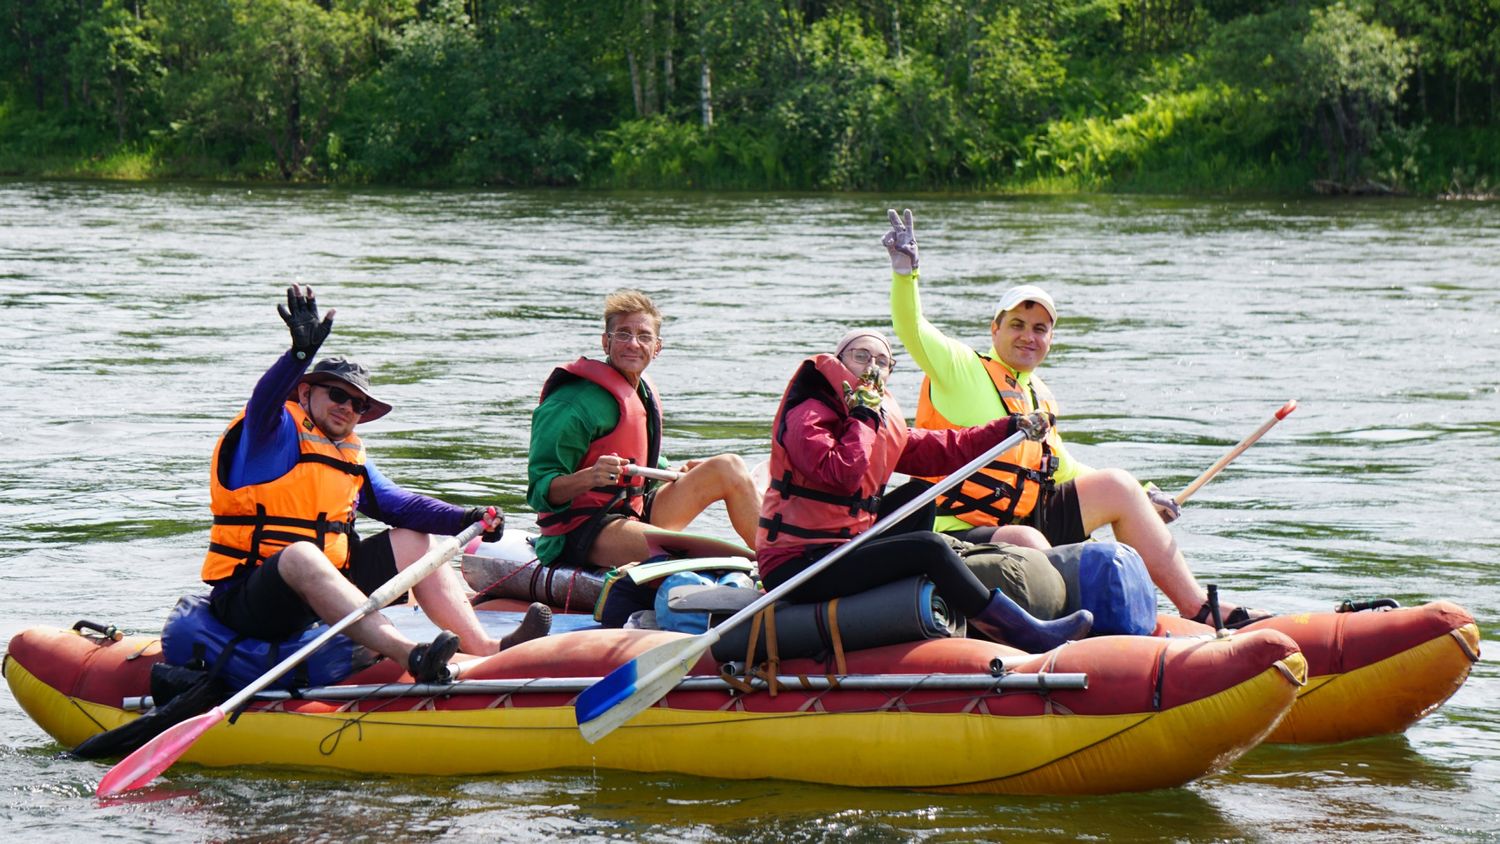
0, 181, 1500, 841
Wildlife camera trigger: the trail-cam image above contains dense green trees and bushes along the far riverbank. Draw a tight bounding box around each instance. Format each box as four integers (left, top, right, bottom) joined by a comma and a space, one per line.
0, 0, 1500, 195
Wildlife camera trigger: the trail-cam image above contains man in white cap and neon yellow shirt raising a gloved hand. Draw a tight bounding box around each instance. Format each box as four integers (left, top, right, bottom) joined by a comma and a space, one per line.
882, 210, 1271, 628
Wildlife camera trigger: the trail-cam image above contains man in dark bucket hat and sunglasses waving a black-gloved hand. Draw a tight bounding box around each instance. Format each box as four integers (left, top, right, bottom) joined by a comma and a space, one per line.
203, 286, 552, 682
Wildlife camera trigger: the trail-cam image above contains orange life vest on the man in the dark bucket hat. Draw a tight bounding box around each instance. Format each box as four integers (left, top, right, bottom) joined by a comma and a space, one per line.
203, 402, 365, 583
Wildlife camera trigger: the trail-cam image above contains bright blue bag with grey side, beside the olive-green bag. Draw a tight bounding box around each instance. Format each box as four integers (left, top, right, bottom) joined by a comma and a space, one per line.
1046, 541, 1157, 636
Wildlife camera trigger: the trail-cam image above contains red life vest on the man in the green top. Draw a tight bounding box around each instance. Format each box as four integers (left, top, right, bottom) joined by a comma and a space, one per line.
537, 357, 662, 537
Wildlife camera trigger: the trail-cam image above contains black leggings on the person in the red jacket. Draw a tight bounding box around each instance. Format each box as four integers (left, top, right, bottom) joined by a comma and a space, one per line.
765, 531, 990, 618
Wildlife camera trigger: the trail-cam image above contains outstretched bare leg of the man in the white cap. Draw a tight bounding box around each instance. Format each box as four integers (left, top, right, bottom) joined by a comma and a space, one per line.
1073, 469, 1233, 618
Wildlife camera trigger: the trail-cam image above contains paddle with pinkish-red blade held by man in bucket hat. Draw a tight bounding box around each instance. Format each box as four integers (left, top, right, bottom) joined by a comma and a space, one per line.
95, 512, 485, 798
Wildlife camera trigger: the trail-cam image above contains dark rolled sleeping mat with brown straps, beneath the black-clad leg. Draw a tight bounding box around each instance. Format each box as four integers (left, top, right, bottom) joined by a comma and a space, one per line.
711, 577, 965, 663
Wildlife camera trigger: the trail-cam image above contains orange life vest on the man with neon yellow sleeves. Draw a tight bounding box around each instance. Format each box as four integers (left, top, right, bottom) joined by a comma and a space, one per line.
917, 355, 1058, 525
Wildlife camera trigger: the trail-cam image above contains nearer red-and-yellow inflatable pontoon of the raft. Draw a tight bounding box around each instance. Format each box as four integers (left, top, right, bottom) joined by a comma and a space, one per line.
5, 620, 1305, 795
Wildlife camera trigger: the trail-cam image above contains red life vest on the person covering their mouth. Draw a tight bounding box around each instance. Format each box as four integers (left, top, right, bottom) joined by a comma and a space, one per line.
756, 355, 906, 576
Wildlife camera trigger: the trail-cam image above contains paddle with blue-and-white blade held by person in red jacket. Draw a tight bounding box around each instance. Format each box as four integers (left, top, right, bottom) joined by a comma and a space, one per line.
573, 432, 1026, 744
